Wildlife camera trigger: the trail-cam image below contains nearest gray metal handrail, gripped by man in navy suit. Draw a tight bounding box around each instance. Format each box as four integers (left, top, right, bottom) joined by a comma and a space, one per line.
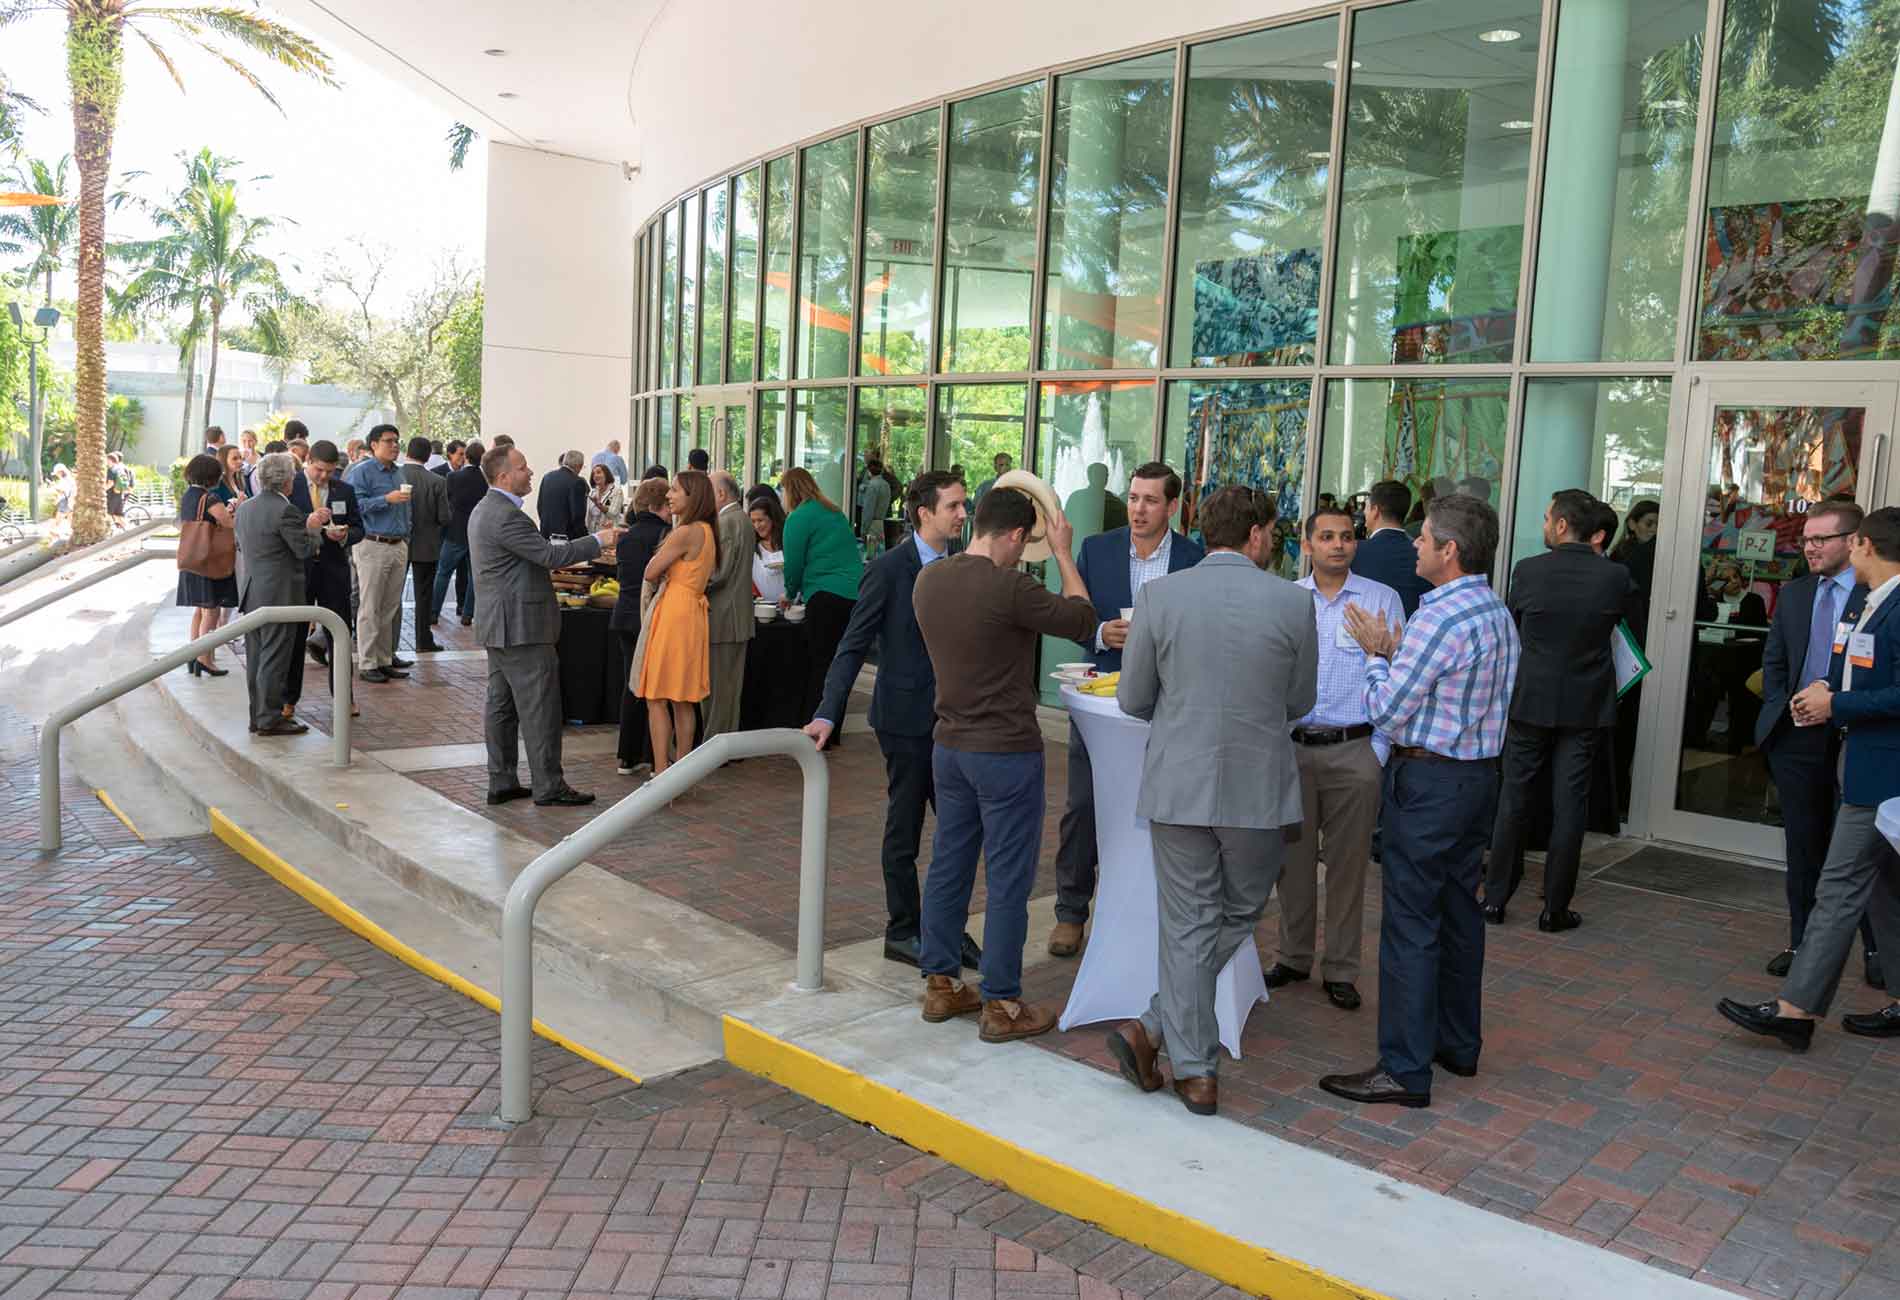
502, 728, 830, 1123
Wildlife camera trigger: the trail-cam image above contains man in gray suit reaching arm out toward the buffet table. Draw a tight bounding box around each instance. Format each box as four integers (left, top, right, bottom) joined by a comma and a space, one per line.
469, 447, 621, 808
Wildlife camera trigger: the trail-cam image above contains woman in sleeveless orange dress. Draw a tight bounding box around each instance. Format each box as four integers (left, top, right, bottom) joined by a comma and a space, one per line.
633, 469, 718, 775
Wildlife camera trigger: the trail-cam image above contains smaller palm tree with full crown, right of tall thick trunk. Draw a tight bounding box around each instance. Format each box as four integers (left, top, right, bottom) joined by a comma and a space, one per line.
114, 148, 285, 452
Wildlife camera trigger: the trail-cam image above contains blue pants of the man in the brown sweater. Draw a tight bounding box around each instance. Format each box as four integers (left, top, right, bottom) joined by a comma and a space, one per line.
922, 745, 1043, 1002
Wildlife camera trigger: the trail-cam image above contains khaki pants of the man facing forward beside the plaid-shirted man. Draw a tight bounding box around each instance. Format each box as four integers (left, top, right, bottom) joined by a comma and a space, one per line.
1279, 737, 1385, 985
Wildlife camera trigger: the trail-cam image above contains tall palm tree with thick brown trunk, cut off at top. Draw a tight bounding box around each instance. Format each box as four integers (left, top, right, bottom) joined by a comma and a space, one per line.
0, 0, 336, 545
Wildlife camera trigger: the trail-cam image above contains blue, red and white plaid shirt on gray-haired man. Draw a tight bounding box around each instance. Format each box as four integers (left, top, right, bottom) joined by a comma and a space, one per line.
1366, 574, 1520, 758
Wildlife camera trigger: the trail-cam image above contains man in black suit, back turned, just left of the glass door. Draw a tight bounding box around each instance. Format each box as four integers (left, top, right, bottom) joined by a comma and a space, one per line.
1484, 488, 1636, 931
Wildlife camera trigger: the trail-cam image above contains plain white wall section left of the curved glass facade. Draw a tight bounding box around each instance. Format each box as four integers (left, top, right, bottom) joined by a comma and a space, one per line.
481, 144, 633, 497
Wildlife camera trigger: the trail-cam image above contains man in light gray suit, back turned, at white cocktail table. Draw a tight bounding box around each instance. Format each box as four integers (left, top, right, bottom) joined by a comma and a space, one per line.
1108, 487, 1319, 1116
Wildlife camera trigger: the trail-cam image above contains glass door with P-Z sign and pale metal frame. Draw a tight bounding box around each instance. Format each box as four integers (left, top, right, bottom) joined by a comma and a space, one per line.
1642, 380, 1894, 861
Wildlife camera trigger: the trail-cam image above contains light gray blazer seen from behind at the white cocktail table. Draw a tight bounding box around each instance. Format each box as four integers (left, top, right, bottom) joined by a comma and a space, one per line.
1115, 551, 1319, 831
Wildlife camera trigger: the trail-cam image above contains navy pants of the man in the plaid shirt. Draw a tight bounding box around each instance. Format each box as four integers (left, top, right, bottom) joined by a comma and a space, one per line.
1379, 755, 1497, 1093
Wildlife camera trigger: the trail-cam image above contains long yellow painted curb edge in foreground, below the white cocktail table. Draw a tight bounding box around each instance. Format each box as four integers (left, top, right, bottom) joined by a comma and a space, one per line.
726, 1015, 1387, 1300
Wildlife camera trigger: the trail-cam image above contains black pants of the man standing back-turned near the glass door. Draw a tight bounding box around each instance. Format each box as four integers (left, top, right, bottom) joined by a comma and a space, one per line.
1484, 722, 1604, 914
